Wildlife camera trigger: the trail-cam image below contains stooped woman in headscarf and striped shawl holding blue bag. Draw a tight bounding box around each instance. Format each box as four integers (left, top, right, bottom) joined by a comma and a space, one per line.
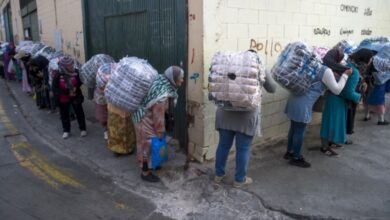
133, 66, 184, 182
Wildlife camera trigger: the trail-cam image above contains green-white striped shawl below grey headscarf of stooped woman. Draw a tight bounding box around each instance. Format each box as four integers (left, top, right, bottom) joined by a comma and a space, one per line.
133, 74, 178, 123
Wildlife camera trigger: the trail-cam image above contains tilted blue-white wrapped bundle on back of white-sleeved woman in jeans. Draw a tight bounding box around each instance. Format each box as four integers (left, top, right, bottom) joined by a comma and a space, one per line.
271, 42, 326, 95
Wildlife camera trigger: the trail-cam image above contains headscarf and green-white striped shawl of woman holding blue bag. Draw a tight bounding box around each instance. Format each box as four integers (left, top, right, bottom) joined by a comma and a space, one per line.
132, 66, 179, 123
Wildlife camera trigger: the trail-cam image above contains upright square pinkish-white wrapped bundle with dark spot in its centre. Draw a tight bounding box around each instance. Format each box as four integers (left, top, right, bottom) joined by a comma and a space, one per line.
209, 51, 265, 111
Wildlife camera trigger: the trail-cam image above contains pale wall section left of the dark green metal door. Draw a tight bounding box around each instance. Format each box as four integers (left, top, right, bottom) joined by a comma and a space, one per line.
37, 0, 85, 62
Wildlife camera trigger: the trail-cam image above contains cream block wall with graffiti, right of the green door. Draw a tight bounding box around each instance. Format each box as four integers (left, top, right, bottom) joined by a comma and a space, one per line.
188, 0, 390, 160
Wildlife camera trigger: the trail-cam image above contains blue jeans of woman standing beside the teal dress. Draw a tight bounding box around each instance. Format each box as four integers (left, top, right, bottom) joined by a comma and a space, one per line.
287, 120, 307, 157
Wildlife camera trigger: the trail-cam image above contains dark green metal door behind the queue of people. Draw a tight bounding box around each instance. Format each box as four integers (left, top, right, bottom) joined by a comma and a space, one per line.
83, 0, 187, 147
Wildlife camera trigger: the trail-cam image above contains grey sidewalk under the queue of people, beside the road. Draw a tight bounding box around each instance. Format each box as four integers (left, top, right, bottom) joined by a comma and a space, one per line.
1, 81, 390, 219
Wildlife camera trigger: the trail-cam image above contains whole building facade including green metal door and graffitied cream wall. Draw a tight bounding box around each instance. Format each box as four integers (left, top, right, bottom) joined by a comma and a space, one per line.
0, 0, 390, 161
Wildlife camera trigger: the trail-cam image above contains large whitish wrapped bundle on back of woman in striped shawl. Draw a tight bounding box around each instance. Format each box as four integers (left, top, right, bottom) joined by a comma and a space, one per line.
105, 57, 158, 112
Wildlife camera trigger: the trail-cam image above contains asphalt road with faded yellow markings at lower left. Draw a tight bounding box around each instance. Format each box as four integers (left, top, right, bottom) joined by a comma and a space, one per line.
0, 82, 171, 220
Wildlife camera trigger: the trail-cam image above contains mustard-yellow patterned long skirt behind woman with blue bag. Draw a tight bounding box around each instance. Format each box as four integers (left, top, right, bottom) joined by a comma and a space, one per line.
108, 107, 136, 154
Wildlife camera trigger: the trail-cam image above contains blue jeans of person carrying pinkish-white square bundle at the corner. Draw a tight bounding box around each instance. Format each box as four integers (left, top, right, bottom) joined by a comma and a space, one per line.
215, 129, 253, 182
